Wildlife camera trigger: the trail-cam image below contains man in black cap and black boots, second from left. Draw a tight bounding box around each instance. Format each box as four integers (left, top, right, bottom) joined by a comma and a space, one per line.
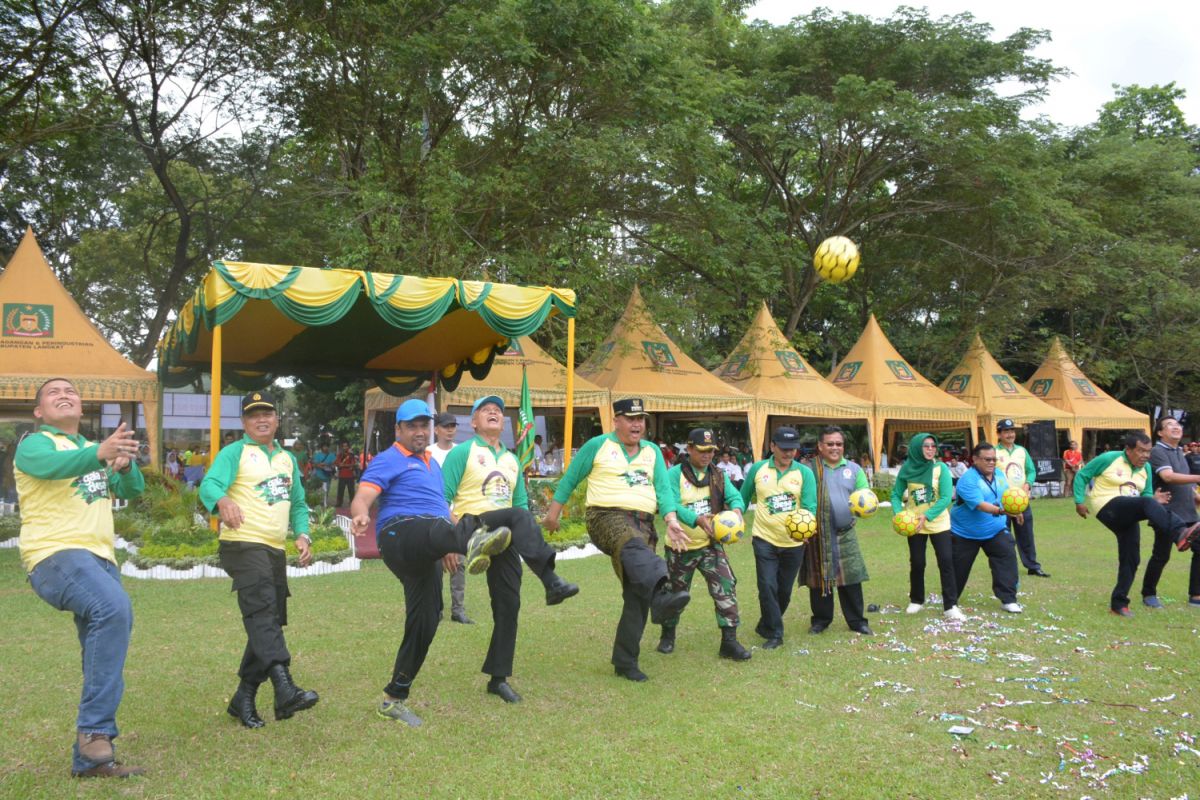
200, 392, 318, 728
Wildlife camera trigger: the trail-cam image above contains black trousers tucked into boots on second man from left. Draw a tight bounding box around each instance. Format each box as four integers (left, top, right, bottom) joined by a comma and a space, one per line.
217, 542, 292, 686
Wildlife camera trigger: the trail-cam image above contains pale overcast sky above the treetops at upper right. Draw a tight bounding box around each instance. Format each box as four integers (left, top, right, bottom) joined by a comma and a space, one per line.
746, 0, 1200, 126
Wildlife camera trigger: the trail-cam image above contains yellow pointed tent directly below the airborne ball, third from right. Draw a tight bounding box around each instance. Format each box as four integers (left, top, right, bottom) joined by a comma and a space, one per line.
829, 314, 976, 469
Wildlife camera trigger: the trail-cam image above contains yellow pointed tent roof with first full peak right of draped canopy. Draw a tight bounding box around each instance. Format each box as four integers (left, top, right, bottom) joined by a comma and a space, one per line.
580, 287, 757, 455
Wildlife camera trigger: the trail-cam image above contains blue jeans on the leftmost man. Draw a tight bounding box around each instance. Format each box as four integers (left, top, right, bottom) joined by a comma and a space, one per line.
29, 549, 133, 771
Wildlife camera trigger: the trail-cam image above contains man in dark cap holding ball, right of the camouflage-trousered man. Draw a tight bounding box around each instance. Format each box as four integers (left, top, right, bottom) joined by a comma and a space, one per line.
742, 427, 817, 650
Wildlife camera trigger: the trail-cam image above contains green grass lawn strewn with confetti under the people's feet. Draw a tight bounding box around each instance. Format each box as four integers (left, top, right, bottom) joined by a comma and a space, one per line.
0, 500, 1200, 800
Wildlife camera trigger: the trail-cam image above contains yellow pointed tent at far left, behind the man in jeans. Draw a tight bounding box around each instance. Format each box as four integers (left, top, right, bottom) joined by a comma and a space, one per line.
0, 230, 160, 465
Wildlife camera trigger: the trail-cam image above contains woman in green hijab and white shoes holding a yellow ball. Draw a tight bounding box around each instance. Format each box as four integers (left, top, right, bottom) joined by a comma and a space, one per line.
892, 433, 966, 621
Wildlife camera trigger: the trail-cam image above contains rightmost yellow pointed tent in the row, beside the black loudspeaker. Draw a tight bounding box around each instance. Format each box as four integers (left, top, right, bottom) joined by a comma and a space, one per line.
1025, 336, 1150, 445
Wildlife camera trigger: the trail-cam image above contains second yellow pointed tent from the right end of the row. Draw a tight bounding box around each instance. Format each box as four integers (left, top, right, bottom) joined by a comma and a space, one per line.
942, 333, 1075, 432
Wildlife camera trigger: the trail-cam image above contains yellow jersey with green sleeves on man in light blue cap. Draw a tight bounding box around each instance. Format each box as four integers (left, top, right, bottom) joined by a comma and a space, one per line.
442, 437, 528, 516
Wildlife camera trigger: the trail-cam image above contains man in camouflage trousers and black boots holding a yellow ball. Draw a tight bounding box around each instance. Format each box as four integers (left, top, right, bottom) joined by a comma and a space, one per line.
658, 428, 750, 661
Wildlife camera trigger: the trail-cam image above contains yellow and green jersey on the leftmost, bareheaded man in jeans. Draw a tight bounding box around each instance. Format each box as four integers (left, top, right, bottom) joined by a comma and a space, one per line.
13, 428, 145, 572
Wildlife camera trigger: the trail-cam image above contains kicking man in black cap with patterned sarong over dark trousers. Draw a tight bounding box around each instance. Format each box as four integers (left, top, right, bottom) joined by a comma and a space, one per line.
541, 398, 690, 681
